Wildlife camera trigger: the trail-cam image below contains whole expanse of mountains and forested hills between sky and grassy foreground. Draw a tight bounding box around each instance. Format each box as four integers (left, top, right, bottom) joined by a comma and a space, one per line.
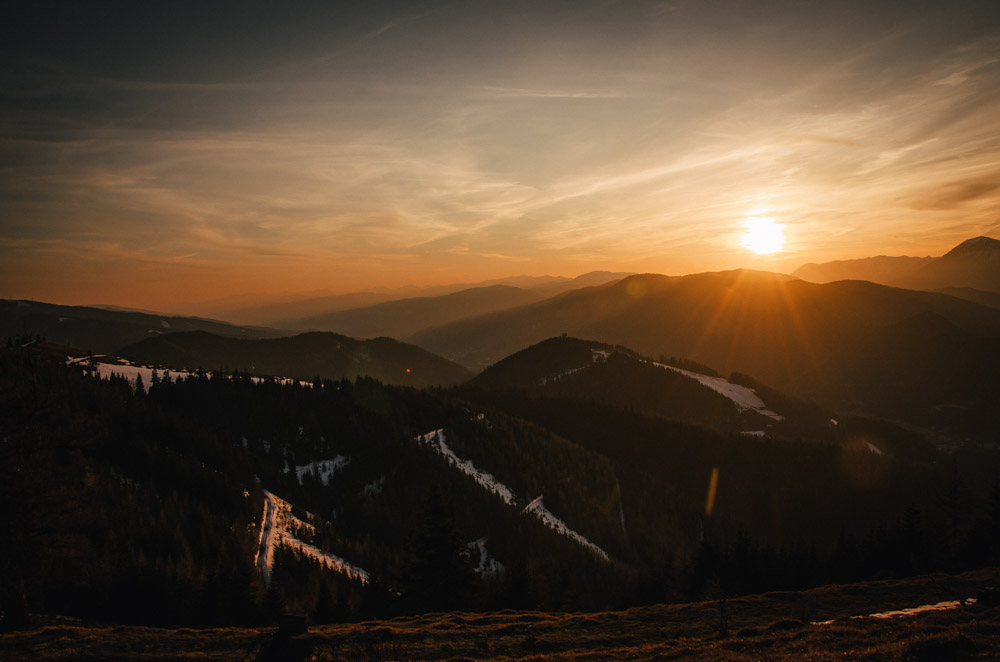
0, 237, 1000, 627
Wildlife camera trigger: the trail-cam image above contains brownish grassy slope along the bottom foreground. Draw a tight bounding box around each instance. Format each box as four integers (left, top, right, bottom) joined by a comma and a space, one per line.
7, 568, 1000, 661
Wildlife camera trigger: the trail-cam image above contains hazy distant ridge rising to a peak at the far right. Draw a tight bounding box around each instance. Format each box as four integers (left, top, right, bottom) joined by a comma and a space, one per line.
792, 237, 1000, 293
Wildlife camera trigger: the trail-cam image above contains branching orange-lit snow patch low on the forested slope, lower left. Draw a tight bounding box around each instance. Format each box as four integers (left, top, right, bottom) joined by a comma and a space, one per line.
254, 490, 370, 584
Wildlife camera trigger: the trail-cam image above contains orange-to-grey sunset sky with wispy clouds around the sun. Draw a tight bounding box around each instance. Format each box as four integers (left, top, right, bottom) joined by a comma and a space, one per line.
0, 0, 1000, 310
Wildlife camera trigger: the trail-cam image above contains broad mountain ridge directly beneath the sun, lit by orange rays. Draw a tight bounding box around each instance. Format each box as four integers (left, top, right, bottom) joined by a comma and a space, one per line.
408, 271, 1000, 440
